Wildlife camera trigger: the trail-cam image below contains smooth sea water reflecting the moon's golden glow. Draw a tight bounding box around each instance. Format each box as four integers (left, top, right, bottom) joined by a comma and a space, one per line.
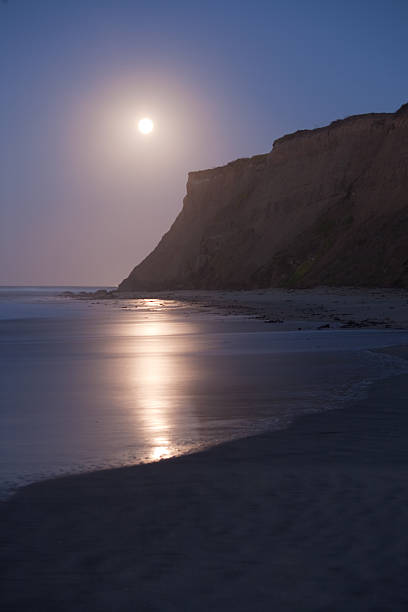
0, 287, 408, 496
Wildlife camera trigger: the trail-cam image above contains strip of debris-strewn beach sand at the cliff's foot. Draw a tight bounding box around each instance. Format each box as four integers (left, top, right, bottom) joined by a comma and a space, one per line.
76, 287, 408, 331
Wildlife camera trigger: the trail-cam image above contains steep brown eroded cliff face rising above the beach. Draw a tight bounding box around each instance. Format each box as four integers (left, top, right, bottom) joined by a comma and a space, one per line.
119, 104, 408, 291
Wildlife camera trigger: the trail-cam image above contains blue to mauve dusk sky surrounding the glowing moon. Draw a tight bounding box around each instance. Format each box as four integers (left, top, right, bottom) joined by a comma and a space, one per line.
0, 0, 408, 286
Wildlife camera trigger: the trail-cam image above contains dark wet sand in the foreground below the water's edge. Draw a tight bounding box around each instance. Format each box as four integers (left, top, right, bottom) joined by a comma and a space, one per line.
0, 347, 408, 612
